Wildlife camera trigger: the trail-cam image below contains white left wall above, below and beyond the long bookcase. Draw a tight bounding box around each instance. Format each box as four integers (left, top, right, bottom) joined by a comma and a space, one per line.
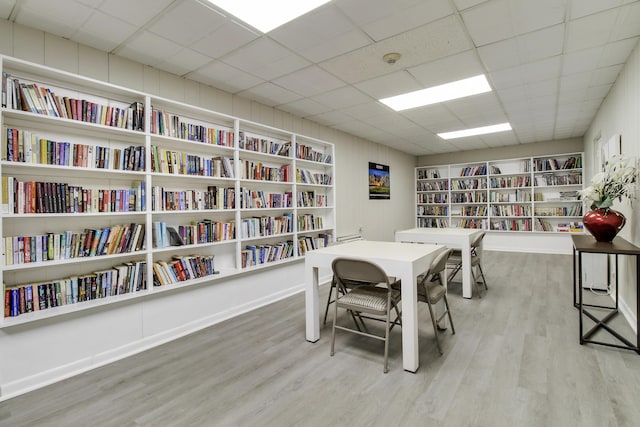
0, 20, 416, 400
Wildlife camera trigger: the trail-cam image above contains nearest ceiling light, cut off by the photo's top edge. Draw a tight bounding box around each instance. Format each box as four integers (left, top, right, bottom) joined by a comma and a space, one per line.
208, 0, 330, 33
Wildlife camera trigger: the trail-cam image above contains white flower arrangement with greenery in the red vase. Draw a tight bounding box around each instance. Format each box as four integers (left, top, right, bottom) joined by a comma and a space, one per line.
579, 155, 638, 210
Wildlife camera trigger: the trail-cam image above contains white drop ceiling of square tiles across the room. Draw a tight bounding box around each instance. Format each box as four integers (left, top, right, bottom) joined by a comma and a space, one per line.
0, 0, 640, 155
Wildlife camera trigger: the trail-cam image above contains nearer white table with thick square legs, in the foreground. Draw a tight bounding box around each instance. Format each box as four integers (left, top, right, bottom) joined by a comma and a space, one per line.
304, 240, 441, 372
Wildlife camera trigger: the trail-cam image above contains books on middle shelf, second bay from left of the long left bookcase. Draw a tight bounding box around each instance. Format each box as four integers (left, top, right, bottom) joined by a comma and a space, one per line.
151, 185, 235, 211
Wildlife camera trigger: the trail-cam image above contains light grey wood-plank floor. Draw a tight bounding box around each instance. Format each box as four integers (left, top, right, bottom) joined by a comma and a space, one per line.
0, 251, 640, 427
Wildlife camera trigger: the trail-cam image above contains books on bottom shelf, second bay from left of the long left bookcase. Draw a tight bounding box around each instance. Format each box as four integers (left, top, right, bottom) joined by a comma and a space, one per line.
153, 255, 219, 286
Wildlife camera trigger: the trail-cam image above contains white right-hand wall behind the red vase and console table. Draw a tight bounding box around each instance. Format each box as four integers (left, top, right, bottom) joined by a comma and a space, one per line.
584, 38, 640, 329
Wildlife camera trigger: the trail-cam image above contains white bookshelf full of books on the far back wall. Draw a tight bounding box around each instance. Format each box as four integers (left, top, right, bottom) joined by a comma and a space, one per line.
416, 153, 583, 233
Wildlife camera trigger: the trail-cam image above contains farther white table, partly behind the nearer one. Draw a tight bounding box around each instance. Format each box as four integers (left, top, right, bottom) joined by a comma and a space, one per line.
396, 228, 483, 298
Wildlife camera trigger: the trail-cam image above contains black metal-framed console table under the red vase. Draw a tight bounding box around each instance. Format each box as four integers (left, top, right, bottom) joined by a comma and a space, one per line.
571, 234, 640, 354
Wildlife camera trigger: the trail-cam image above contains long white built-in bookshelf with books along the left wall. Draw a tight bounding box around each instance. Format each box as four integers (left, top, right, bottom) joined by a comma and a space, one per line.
0, 57, 336, 327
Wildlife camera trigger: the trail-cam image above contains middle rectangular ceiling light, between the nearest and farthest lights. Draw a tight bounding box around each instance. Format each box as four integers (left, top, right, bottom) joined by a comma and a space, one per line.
380, 74, 491, 111
